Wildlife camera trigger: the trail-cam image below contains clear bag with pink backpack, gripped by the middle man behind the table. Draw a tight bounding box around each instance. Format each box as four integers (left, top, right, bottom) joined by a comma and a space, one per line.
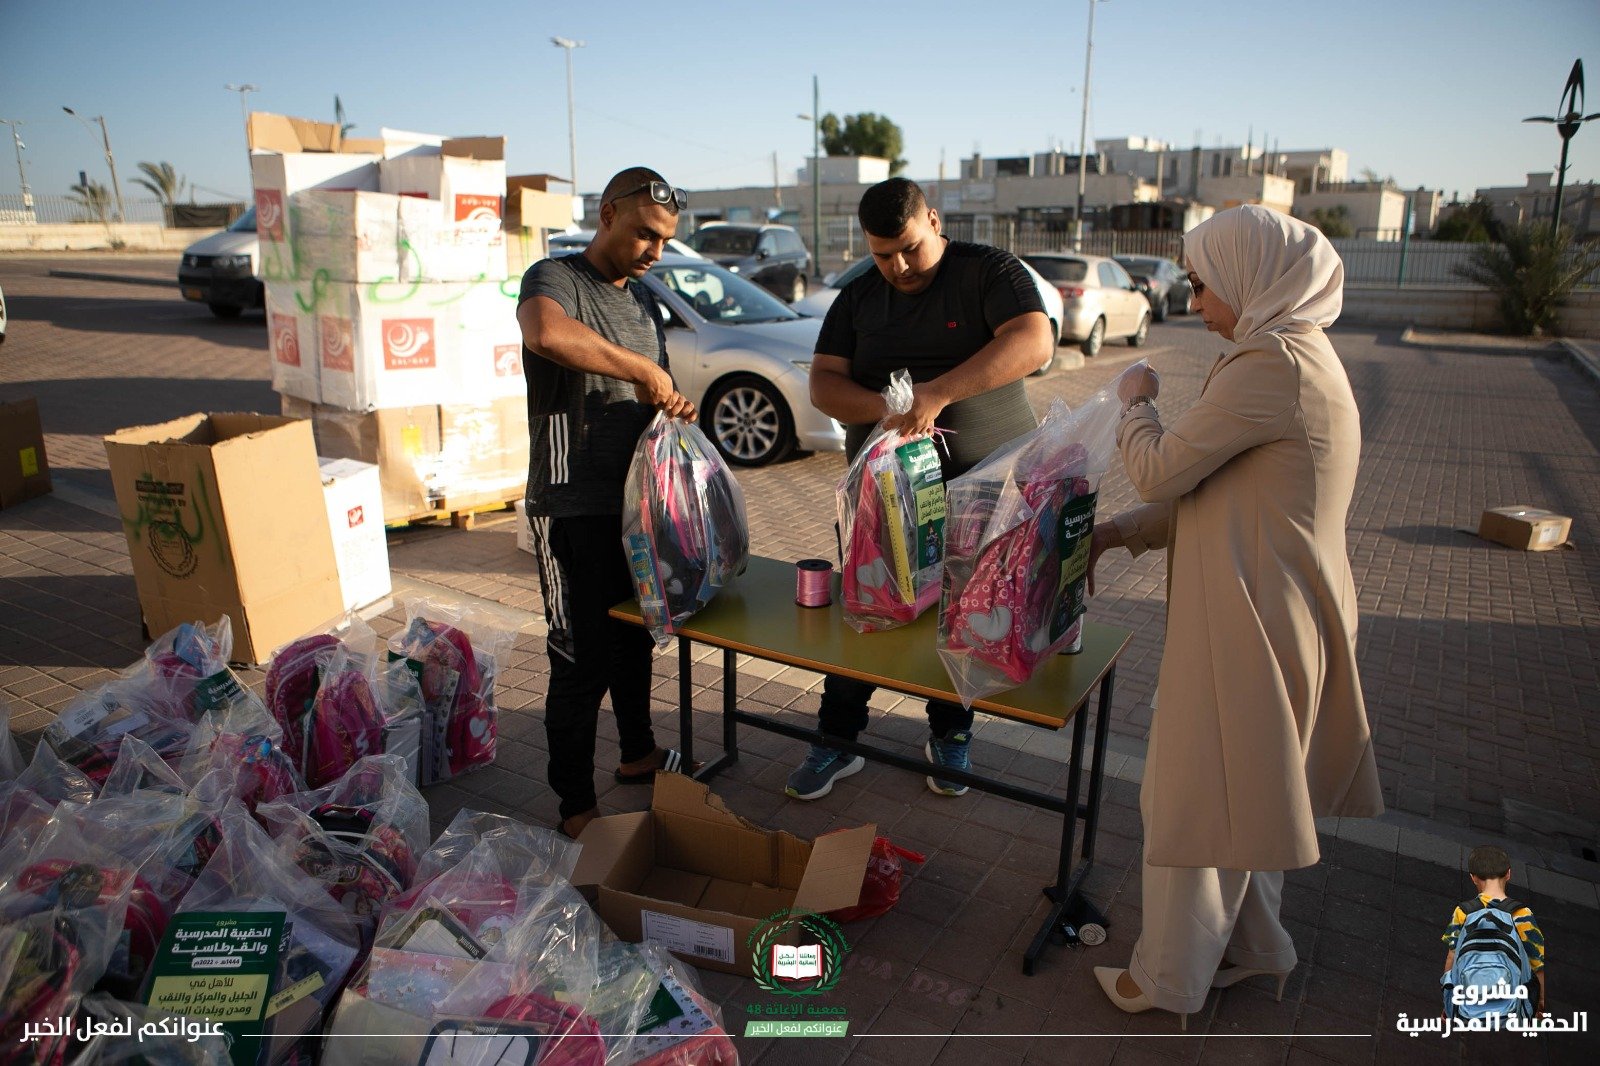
835, 370, 946, 632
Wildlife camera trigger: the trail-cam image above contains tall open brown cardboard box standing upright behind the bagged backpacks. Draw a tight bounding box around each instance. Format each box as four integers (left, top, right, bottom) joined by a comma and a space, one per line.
106, 415, 344, 663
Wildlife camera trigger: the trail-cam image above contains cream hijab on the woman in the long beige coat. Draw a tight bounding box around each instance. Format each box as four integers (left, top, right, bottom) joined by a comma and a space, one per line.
1184, 205, 1344, 344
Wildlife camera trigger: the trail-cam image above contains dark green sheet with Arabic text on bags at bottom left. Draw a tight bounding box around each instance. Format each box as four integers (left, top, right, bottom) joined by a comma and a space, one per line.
146, 911, 285, 1066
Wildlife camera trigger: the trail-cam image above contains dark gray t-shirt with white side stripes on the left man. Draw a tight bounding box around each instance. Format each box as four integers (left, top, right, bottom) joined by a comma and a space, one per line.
517, 254, 667, 519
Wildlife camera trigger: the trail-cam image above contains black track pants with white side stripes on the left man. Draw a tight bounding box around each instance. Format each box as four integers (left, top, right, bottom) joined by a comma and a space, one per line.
528, 514, 656, 820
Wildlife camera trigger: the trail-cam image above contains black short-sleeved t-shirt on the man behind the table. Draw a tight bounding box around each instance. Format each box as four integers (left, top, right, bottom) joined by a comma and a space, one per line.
816, 240, 1045, 477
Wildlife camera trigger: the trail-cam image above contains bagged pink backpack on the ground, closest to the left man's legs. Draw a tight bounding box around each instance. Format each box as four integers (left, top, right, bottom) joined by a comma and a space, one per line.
390, 599, 517, 784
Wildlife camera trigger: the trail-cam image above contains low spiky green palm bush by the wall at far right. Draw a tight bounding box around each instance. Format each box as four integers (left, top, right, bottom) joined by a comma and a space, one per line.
1456, 222, 1600, 336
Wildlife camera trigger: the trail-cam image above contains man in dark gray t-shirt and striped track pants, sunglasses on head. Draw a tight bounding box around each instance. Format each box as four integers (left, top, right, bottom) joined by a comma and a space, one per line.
517, 166, 696, 837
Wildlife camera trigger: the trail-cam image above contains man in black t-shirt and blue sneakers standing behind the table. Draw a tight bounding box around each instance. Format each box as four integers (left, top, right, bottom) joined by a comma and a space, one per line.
787, 178, 1054, 799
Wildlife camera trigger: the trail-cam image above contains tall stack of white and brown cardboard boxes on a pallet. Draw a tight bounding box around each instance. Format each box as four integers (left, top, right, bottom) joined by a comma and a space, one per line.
250, 114, 528, 523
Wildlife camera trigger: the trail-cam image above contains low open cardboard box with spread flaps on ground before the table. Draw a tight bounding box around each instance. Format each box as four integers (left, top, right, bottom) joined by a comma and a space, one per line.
573, 773, 877, 976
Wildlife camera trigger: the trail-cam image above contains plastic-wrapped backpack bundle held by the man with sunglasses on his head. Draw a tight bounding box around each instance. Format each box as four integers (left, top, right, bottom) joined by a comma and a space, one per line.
622, 415, 750, 647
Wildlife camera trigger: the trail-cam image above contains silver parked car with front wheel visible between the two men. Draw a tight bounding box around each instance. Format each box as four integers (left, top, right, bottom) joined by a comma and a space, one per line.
560, 251, 845, 466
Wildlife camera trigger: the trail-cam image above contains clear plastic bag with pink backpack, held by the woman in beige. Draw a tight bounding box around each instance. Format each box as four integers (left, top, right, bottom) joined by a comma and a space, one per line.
938, 384, 1122, 706
